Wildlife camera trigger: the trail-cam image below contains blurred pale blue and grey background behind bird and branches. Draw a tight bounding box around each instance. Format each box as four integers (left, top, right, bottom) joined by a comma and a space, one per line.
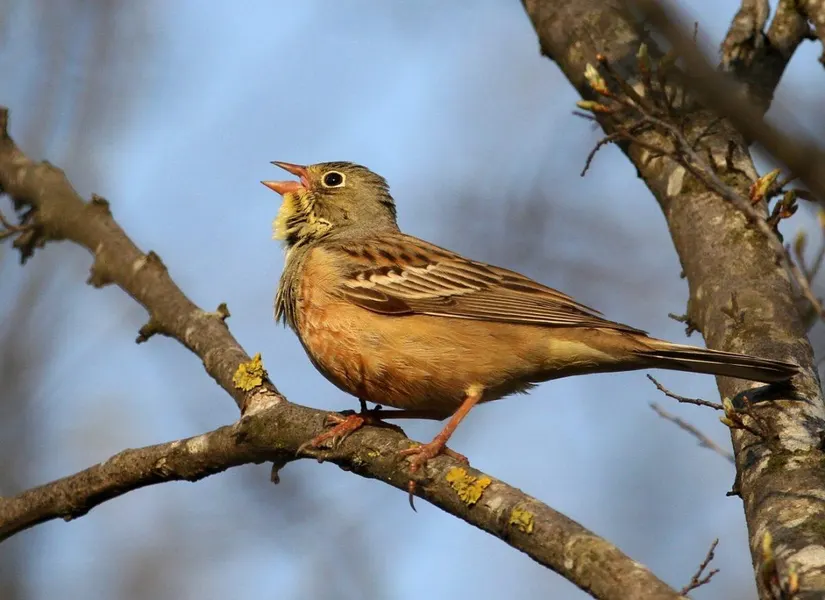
0, 0, 825, 600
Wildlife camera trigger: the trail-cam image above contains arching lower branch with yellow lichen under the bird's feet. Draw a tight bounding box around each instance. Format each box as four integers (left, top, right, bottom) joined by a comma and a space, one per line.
0, 402, 680, 600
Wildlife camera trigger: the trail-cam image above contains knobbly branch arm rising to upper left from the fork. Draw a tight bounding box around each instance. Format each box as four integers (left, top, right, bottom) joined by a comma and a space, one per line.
0, 107, 260, 407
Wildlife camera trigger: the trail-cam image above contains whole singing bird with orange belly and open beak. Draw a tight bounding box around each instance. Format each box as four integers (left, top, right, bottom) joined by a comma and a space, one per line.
262, 162, 798, 472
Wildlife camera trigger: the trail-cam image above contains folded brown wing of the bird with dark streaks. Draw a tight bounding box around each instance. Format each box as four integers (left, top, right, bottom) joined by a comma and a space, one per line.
329, 233, 644, 334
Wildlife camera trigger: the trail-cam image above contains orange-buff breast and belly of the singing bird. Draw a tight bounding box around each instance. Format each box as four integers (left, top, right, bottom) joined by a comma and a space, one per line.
297, 303, 546, 416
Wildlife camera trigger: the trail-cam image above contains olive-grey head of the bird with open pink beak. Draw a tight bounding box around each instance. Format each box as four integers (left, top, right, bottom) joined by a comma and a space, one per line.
261, 161, 398, 247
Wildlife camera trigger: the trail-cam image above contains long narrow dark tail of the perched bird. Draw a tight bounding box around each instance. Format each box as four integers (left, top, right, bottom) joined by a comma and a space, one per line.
641, 339, 799, 383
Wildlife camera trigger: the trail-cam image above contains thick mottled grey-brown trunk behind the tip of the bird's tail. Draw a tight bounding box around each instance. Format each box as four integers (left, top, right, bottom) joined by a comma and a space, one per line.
524, 0, 825, 599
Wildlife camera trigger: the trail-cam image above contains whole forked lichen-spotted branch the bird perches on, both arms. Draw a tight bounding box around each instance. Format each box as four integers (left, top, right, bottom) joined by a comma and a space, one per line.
0, 108, 681, 600
